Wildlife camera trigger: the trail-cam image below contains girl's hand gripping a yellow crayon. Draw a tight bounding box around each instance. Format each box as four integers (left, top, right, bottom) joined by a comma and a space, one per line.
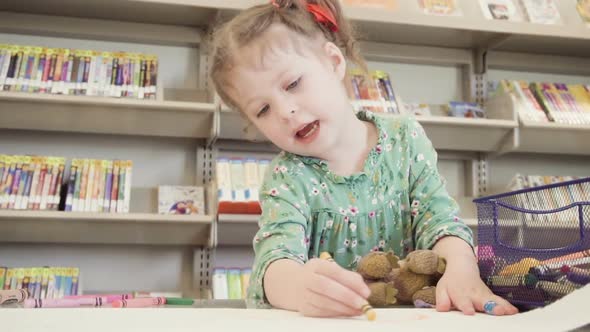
297, 258, 371, 317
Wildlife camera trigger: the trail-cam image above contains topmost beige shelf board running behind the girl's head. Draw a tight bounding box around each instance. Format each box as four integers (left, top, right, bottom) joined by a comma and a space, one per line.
0, 0, 590, 56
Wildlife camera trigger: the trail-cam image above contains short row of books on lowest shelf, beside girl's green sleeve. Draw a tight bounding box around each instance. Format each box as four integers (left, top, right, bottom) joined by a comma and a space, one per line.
211, 267, 252, 300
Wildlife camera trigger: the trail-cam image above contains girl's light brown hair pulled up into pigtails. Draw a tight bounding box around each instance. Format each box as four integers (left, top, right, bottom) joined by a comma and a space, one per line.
209, 0, 366, 109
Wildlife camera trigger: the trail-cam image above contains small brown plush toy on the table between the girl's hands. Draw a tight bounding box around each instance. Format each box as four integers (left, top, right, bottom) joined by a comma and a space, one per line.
357, 250, 446, 307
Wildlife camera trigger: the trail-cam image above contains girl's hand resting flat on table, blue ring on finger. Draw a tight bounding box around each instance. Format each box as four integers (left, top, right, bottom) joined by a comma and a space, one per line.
436, 259, 518, 316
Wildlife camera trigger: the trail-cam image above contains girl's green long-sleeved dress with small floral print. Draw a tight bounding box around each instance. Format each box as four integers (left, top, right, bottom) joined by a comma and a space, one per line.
247, 112, 473, 308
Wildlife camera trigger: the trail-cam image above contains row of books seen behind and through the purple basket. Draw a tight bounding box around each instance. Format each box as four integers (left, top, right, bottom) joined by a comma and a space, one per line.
508, 174, 590, 224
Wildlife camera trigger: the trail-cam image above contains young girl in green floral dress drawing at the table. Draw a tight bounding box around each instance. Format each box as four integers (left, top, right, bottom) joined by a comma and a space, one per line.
211, 0, 517, 317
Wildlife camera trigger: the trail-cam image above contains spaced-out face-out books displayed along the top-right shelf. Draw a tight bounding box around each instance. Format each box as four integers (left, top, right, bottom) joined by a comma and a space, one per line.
344, 0, 590, 24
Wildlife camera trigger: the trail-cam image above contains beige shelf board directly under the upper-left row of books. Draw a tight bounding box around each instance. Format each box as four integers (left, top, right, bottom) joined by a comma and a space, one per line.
0, 92, 215, 139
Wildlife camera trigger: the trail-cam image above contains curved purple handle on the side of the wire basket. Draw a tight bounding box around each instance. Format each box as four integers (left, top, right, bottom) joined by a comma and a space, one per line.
492, 201, 588, 253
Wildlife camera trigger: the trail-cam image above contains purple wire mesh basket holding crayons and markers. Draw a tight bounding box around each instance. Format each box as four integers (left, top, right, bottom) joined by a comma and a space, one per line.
473, 178, 590, 310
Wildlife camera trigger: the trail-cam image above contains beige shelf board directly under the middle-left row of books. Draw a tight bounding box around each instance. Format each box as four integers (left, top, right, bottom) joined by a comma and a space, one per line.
0, 210, 213, 246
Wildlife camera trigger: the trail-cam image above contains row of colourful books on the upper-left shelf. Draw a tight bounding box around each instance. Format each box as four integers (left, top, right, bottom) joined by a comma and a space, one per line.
0, 44, 158, 99
